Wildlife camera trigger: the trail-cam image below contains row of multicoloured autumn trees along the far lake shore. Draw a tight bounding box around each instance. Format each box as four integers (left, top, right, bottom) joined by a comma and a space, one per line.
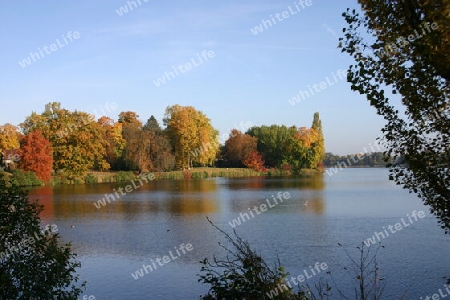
0, 102, 325, 182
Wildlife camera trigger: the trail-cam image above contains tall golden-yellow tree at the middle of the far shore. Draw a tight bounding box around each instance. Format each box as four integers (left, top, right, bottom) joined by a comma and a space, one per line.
164, 105, 219, 169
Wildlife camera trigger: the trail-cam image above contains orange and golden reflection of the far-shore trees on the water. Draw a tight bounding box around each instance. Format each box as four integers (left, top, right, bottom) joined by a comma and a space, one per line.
30, 174, 325, 219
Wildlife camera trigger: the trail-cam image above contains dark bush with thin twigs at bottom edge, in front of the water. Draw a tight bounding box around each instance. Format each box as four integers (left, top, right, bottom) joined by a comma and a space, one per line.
198, 218, 390, 300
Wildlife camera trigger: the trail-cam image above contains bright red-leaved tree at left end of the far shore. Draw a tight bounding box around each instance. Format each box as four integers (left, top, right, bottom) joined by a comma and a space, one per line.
18, 131, 53, 182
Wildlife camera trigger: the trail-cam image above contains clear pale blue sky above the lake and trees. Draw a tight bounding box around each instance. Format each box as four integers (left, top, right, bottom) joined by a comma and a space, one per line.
0, 0, 384, 154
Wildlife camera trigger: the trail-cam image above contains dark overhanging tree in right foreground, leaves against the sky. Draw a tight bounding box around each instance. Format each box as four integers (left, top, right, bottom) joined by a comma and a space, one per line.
340, 0, 450, 233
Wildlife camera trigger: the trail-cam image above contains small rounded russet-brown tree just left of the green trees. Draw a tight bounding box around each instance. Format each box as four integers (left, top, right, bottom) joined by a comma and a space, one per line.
224, 129, 258, 167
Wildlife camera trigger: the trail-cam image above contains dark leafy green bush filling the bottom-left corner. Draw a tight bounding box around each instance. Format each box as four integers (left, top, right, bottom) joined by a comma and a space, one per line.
0, 175, 85, 300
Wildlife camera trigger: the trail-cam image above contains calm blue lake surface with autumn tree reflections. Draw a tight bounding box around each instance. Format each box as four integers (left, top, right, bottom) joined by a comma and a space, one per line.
30, 168, 450, 299
